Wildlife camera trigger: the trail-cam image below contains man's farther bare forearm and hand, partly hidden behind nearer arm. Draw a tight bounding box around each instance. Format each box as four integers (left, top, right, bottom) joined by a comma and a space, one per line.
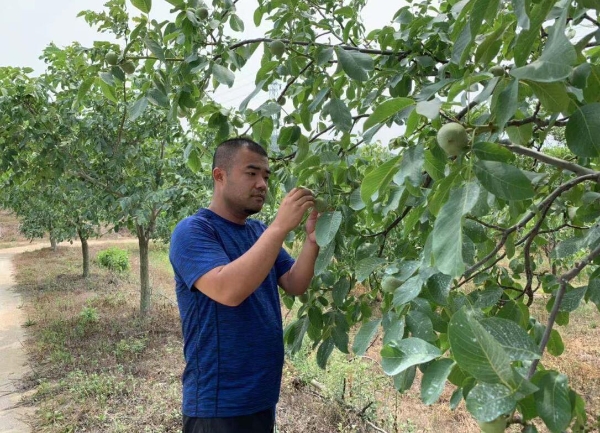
279, 210, 319, 296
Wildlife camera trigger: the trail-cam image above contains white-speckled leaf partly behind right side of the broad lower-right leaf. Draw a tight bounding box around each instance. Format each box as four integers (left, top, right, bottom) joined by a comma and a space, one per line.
480, 317, 540, 361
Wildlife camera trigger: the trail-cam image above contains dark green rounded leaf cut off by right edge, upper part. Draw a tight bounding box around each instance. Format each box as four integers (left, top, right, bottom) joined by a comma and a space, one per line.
565, 102, 600, 158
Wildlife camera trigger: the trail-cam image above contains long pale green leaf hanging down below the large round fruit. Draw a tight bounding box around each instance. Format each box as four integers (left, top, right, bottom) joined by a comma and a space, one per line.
430, 183, 479, 277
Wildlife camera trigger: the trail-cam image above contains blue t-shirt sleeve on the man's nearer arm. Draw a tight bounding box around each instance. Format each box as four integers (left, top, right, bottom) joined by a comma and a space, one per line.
169, 219, 231, 289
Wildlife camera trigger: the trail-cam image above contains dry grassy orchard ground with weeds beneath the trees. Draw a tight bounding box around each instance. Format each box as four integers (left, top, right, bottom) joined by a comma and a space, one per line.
0, 213, 600, 433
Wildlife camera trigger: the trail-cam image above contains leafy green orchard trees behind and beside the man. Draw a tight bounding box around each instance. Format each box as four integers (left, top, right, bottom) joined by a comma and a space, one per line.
0, 0, 600, 432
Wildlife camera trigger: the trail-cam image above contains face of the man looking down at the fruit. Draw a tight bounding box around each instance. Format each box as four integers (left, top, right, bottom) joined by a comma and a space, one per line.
222, 147, 271, 216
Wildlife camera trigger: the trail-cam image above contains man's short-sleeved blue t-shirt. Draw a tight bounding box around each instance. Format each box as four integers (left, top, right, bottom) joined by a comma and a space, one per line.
169, 209, 294, 418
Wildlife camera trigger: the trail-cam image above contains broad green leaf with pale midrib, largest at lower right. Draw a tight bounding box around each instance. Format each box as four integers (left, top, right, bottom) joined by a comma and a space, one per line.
448, 307, 513, 385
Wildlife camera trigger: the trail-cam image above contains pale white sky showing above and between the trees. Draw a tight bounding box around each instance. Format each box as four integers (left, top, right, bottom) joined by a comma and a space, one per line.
0, 0, 402, 140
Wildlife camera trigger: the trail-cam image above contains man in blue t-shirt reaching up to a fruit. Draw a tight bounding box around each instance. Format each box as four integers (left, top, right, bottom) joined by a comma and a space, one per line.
169, 138, 319, 433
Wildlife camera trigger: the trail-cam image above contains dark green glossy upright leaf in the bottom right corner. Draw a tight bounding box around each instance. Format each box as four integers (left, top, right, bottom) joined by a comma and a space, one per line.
533, 371, 572, 433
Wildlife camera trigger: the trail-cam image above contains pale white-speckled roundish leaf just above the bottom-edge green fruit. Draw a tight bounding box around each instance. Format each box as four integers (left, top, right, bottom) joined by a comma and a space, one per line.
466, 383, 517, 422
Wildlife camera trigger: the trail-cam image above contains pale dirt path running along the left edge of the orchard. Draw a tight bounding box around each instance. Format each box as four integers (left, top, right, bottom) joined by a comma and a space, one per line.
0, 239, 137, 433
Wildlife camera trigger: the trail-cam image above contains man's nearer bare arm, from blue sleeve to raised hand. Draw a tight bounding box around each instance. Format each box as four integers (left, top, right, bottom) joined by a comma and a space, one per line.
194, 189, 314, 307
